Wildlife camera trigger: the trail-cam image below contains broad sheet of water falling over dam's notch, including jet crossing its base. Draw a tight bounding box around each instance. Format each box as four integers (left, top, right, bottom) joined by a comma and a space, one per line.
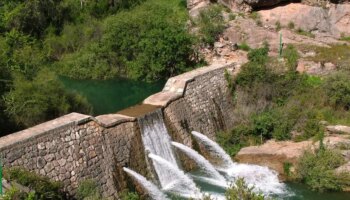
139, 109, 199, 197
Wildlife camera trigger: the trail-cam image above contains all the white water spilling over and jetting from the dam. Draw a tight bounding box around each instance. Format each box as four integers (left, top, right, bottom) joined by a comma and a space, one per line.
124, 109, 286, 200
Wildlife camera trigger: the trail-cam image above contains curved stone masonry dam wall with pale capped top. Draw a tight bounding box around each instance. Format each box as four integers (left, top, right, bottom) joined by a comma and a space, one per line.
0, 63, 237, 199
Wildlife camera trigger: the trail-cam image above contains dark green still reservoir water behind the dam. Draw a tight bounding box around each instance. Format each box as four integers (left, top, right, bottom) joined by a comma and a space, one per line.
60, 77, 165, 115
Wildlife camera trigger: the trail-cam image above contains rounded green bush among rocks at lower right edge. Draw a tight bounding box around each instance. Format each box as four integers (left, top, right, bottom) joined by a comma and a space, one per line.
297, 148, 350, 192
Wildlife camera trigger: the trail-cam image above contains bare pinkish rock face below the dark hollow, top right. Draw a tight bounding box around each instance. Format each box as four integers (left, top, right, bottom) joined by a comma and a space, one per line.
259, 3, 350, 38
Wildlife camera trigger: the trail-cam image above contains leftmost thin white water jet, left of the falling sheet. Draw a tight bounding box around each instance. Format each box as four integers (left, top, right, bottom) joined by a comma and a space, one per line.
123, 167, 168, 200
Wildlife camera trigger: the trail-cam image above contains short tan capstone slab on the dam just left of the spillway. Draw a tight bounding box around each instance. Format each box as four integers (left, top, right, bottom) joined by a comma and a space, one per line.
95, 114, 136, 128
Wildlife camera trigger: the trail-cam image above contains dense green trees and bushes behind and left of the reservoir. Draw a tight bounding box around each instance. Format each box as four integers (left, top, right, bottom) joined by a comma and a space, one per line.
0, 0, 200, 134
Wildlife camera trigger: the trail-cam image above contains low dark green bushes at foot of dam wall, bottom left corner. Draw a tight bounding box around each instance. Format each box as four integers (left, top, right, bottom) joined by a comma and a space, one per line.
4, 168, 66, 200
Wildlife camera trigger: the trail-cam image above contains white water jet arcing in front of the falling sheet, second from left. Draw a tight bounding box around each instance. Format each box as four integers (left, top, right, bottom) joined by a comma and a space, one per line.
148, 154, 201, 198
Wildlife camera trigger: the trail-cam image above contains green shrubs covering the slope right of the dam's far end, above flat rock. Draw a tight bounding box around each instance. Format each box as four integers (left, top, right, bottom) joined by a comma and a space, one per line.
217, 45, 350, 155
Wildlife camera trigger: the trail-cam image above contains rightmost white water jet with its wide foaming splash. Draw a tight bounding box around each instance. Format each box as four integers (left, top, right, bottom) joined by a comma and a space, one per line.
192, 131, 286, 194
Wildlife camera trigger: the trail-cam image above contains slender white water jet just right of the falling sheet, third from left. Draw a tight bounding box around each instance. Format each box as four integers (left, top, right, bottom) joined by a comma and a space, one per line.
171, 142, 226, 185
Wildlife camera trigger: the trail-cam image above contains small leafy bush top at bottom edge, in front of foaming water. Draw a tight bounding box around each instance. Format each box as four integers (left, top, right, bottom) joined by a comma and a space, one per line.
225, 178, 265, 200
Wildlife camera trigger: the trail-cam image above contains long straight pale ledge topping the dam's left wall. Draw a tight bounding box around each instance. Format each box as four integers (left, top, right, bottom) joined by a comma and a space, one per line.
0, 113, 93, 149
